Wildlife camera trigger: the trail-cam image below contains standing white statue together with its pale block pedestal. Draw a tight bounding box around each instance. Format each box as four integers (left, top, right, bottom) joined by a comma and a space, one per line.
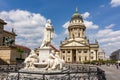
39, 19, 54, 64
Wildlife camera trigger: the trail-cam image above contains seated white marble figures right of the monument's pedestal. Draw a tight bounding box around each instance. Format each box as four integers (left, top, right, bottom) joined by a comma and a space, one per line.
45, 50, 64, 70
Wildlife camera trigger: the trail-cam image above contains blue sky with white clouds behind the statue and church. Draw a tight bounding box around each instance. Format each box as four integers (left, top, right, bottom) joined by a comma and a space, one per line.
0, 0, 120, 55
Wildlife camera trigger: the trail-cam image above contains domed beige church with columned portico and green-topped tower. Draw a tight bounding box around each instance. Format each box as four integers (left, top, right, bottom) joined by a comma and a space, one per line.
60, 9, 99, 63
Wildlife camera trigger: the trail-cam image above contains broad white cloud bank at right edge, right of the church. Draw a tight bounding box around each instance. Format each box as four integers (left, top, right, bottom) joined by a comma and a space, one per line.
95, 29, 120, 54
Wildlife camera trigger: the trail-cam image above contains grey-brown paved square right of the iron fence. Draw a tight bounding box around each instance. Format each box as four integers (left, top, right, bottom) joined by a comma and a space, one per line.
99, 65, 120, 80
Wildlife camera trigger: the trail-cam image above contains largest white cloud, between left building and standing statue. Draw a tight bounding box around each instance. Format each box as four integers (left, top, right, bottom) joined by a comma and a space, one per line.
0, 9, 46, 48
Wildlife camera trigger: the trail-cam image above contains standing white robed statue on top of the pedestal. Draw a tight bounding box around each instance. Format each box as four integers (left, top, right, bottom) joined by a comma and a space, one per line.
41, 19, 54, 48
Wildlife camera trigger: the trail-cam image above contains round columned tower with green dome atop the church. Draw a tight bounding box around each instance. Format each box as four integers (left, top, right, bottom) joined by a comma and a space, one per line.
68, 8, 86, 39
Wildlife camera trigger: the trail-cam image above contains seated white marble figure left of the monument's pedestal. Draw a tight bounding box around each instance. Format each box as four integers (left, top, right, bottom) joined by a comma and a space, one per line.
24, 50, 39, 69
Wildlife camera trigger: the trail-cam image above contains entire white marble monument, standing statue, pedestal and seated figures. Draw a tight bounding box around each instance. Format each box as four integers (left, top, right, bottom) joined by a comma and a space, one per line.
24, 19, 64, 70
